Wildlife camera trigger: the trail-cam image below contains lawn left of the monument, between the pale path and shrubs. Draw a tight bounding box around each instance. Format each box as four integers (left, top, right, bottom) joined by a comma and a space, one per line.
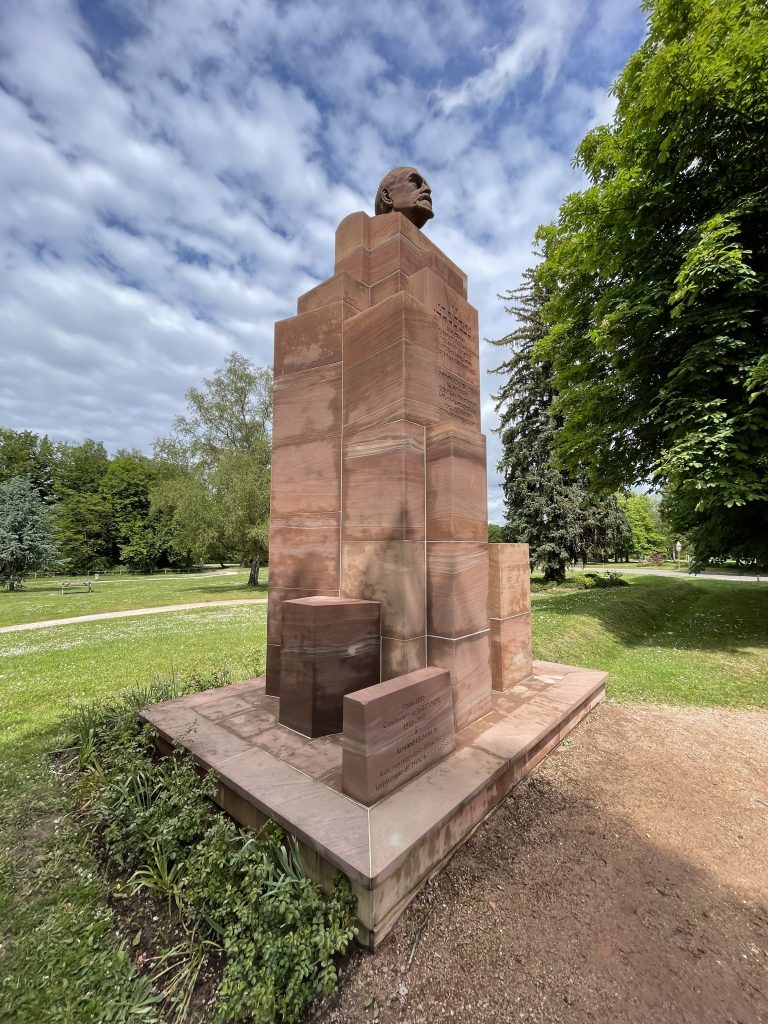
0, 595, 266, 1024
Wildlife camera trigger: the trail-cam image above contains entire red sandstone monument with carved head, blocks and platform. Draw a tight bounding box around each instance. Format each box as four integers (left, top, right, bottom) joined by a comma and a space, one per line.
142, 167, 605, 947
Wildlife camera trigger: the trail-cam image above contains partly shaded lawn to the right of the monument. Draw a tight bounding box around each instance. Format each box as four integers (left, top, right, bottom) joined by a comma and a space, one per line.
532, 575, 768, 708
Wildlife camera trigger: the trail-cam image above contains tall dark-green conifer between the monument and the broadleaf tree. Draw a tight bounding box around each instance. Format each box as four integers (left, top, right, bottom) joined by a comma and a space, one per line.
493, 269, 627, 582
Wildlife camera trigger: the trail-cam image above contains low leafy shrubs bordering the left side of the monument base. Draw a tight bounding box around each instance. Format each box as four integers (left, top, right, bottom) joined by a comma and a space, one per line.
64, 677, 354, 1024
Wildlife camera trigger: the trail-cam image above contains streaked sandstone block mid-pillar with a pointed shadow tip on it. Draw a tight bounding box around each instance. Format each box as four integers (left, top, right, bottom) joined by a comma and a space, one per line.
342, 420, 424, 541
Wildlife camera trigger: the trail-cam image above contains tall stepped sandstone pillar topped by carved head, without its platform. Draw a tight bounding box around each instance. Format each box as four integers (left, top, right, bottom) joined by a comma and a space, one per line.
266, 167, 531, 761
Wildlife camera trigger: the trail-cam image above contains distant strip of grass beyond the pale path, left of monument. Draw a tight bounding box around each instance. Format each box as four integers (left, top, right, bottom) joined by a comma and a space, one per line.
0, 568, 267, 626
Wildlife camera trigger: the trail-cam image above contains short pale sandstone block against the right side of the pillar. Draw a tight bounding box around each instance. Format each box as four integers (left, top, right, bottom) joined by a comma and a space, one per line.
488, 544, 532, 690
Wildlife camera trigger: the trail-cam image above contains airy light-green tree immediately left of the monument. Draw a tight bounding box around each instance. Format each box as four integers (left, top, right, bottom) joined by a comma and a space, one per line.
152, 352, 272, 586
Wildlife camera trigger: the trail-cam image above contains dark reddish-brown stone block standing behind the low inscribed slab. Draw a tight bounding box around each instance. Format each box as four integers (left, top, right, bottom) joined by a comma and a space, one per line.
280, 597, 380, 737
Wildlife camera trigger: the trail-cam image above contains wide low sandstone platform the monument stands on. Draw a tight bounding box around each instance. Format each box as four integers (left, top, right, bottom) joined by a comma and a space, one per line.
140, 662, 607, 949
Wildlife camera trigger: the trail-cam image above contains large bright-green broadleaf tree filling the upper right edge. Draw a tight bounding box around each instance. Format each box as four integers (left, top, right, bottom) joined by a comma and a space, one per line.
537, 0, 768, 558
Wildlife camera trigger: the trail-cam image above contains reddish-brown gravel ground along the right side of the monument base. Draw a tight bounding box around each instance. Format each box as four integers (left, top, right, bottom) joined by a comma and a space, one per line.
314, 705, 768, 1024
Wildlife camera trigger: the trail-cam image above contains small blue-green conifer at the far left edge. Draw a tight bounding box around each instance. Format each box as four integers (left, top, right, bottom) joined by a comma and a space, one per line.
0, 476, 56, 590
